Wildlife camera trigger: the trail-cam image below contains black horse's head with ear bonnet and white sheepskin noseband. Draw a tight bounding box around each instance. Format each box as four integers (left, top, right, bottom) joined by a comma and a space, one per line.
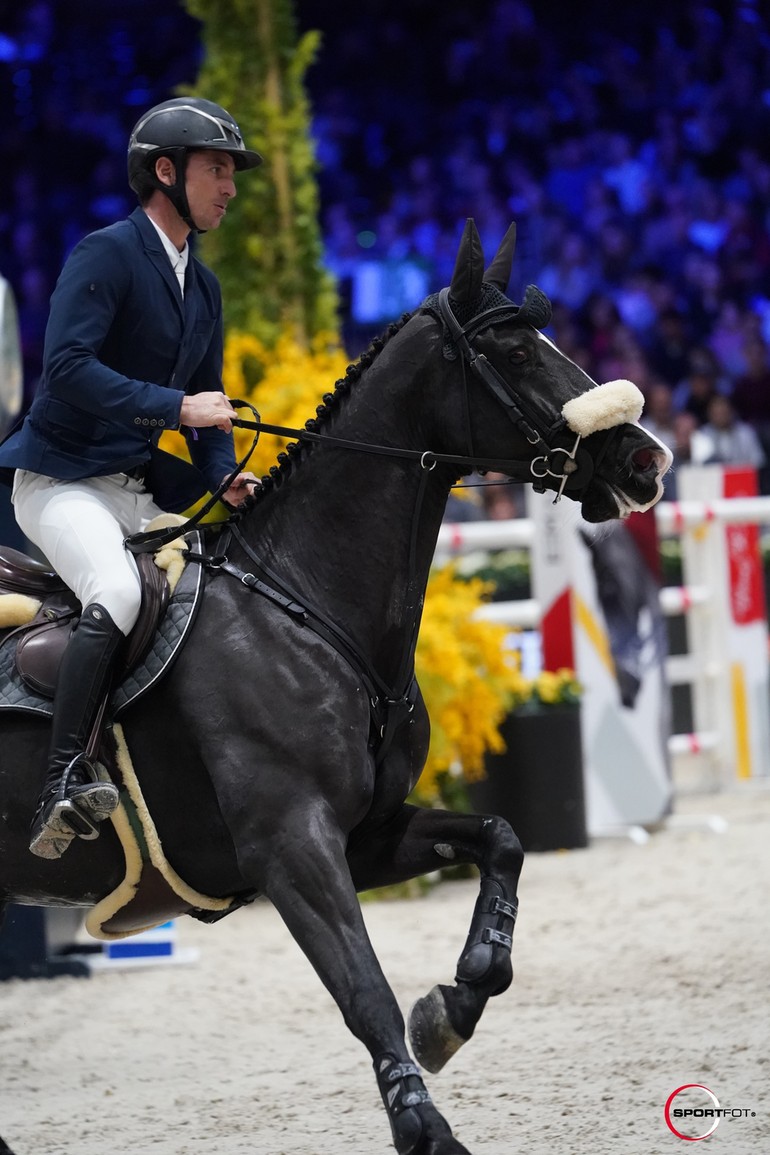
425, 221, 672, 522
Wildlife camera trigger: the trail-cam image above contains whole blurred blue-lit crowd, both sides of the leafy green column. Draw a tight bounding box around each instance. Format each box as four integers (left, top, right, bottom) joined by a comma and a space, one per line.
0, 0, 770, 492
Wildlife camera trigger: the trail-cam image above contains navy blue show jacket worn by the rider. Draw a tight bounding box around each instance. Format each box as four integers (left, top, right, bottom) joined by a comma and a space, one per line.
0, 208, 236, 512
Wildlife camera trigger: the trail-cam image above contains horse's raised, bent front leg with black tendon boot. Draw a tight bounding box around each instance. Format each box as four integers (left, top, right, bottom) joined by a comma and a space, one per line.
347, 804, 523, 1072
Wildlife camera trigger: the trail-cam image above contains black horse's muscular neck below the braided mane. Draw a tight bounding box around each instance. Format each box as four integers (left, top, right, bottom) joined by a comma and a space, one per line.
235, 332, 451, 679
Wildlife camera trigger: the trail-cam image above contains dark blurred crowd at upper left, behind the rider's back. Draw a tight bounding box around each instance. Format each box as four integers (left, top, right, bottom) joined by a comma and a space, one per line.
0, 0, 200, 400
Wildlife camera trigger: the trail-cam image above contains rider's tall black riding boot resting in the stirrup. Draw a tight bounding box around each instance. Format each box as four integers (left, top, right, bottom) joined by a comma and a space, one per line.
29, 602, 124, 858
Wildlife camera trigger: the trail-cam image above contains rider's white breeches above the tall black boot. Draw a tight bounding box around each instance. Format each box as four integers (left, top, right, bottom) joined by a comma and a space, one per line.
12, 469, 163, 634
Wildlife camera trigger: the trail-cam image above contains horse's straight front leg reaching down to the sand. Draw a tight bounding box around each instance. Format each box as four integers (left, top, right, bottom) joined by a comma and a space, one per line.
262, 813, 470, 1155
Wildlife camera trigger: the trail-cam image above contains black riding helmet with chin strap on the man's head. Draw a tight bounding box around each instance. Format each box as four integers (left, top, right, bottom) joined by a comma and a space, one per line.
128, 96, 262, 231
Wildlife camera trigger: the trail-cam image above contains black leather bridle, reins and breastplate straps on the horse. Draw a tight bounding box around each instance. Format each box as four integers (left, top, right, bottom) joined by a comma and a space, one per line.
125, 289, 593, 765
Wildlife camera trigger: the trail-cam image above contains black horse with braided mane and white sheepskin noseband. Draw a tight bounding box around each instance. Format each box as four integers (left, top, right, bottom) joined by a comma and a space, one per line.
0, 221, 670, 1155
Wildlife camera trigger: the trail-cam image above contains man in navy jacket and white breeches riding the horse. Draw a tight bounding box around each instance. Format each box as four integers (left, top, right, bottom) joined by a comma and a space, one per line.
0, 97, 261, 858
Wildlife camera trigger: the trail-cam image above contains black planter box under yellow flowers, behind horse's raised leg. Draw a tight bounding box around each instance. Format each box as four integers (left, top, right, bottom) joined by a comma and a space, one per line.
468, 706, 589, 851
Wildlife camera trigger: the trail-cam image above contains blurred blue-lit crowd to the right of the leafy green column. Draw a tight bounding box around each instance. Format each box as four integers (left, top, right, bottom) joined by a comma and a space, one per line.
304, 0, 770, 496
